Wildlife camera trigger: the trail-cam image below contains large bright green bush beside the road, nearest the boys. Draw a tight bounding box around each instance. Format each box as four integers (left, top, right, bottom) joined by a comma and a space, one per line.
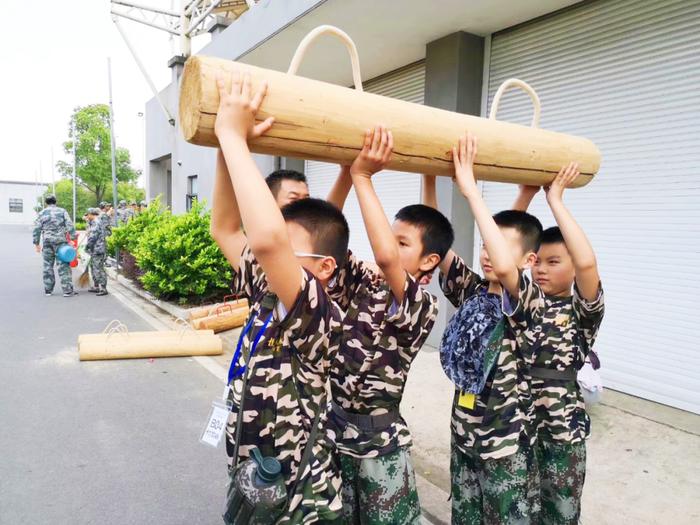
135, 199, 231, 302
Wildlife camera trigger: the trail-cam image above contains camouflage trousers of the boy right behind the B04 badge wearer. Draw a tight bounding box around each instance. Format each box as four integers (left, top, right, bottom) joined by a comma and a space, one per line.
340, 447, 421, 525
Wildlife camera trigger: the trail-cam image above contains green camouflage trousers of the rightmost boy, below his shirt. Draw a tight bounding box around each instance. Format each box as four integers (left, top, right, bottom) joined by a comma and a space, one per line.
537, 440, 586, 525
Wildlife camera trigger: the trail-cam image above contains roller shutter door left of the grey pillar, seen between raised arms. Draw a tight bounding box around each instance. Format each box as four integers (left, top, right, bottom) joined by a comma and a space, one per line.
306, 62, 425, 260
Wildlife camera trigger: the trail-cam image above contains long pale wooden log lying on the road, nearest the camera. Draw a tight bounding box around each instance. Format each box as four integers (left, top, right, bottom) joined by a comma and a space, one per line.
78, 331, 223, 361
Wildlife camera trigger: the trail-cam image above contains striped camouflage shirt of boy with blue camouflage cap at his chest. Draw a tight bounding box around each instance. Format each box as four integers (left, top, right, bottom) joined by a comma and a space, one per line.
440, 256, 544, 459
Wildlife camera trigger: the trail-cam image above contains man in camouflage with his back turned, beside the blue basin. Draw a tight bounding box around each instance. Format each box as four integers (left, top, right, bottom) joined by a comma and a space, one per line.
32, 195, 78, 297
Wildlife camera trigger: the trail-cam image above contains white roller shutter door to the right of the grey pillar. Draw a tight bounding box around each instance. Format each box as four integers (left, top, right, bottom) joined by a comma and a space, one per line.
484, 0, 700, 413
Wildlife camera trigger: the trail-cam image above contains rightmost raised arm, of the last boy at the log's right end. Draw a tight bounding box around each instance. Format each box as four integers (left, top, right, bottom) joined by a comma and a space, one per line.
546, 162, 600, 301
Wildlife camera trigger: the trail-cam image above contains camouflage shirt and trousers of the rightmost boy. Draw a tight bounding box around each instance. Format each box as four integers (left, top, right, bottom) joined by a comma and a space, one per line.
523, 284, 604, 524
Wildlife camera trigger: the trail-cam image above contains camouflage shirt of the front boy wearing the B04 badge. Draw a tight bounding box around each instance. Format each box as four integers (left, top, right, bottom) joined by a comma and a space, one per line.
226, 247, 343, 523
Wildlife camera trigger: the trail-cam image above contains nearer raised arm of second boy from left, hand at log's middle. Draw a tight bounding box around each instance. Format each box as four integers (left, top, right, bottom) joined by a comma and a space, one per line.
350, 126, 406, 303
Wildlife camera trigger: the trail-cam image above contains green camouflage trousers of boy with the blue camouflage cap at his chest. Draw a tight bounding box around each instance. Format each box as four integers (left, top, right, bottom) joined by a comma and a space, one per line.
450, 442, 539, 525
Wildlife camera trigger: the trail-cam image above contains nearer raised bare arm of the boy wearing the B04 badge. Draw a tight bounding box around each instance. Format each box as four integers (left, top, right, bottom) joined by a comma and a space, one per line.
214, 72, 303, 310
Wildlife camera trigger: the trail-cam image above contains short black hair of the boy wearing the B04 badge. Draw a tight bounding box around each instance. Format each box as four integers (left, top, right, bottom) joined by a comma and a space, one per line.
282, 198, 350, 267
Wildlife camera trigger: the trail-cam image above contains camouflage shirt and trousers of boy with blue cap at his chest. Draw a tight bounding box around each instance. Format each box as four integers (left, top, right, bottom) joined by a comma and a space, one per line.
440, 256, 540, 524
